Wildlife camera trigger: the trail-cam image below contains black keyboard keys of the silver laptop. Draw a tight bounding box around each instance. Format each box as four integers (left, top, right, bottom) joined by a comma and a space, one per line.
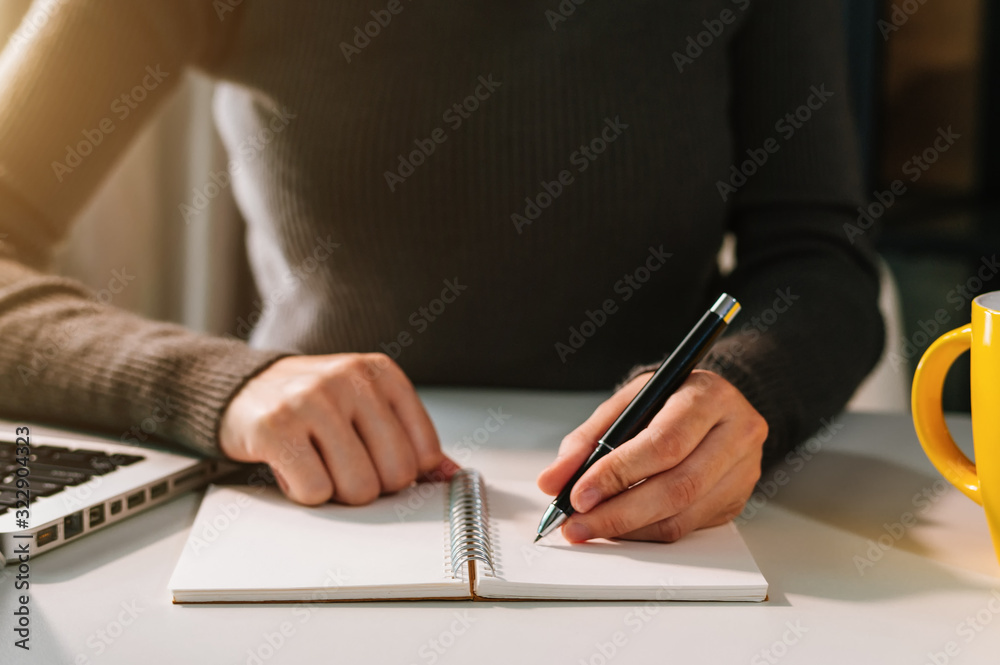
0, 441, 145, 515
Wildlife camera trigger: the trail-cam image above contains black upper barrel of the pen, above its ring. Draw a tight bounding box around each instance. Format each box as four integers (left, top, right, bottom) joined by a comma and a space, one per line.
600, 311, 727, 449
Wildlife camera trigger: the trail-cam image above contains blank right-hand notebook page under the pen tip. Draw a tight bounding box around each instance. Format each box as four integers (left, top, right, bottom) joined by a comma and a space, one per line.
476, 478, 767, 600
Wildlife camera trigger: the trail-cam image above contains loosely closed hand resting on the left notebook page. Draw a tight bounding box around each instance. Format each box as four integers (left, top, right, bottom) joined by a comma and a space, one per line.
219, 353, 458, 505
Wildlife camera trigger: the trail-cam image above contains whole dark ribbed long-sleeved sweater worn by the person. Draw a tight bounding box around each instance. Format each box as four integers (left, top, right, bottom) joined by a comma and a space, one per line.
0, 0, 882, 464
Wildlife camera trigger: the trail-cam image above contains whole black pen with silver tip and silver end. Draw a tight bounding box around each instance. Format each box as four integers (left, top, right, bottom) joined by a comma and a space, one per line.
535, 293, 740, 543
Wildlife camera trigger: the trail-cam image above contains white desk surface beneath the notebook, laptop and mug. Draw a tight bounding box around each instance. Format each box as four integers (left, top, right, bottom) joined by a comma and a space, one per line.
0, 390, 1000, 665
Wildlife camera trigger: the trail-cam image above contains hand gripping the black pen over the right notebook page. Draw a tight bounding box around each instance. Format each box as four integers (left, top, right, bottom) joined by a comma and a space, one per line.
538, 370, 767, 542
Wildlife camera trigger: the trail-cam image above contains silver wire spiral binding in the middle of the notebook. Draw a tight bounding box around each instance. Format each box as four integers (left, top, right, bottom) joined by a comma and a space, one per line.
448, 469, 496, 576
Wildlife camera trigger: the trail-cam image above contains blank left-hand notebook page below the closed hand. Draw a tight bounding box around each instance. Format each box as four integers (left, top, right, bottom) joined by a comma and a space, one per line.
169, 484, 469, 602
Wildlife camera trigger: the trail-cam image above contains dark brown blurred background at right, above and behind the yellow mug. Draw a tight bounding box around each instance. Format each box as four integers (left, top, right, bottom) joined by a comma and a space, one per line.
848, 0, 1000, 411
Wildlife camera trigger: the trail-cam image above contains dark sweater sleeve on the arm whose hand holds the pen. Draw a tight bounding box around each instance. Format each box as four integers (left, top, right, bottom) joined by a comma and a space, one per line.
630, 0, 883, 464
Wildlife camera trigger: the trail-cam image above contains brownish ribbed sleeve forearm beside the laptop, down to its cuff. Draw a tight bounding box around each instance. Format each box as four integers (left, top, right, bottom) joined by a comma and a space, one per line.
0, 259, 284, 455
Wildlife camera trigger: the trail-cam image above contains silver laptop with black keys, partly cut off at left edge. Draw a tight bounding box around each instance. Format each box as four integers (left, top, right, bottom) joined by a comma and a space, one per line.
0, 420, 237, 566
